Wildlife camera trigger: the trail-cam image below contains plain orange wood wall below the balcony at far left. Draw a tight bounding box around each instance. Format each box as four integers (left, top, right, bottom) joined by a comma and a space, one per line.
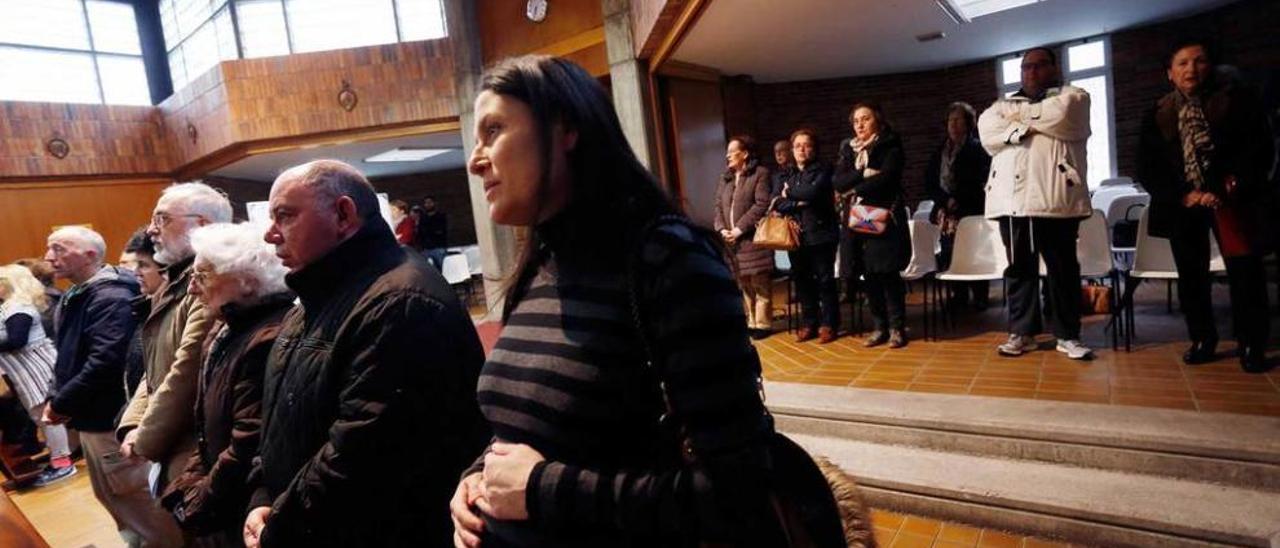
0, 178, 169, 264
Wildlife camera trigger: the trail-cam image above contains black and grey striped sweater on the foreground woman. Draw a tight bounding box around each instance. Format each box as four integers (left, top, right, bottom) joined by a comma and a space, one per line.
474, 217, 772, 545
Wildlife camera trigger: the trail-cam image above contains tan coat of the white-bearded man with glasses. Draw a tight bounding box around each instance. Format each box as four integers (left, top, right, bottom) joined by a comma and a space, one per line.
116, 260, 212, 479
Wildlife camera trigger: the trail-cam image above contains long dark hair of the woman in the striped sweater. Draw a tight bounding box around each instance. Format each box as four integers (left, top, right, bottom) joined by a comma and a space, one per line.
480, 55, 680, 323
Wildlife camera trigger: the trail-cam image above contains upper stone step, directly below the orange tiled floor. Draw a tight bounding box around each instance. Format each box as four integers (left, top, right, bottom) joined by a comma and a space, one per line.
765, 383, 1280, 492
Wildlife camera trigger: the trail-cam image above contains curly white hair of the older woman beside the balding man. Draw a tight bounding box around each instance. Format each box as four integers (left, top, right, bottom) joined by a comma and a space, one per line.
191, 223, 288, 302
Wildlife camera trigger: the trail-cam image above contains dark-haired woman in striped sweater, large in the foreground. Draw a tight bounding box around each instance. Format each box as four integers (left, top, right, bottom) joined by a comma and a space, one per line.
451, 56, 783, 548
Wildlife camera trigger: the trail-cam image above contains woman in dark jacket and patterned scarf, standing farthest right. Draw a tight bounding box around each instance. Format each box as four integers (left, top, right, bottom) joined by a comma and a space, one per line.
1138, 41, 1275, 373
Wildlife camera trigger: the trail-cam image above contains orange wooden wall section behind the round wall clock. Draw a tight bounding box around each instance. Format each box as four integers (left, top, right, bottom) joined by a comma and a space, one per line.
476, 0, 608, 67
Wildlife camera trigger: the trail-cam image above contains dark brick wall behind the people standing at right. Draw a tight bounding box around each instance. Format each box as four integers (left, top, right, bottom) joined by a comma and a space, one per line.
722, 0, 1280, 202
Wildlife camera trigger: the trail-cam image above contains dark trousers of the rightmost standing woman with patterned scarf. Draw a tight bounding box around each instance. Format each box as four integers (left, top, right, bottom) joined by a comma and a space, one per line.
1169, 216, 1271, 346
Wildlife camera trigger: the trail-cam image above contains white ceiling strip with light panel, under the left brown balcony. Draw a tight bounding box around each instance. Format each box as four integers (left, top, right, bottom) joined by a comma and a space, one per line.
212, 132, 466, 182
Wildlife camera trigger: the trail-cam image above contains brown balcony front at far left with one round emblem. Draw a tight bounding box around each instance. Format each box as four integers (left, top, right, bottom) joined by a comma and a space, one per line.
0, 101, 174, 177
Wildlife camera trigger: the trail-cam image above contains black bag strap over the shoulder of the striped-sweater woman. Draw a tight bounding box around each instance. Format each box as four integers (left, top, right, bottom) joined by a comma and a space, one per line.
627, 215, 762, 463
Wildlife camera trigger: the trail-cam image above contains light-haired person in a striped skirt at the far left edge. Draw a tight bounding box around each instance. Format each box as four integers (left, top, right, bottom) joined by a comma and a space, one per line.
0, 265, 76, 487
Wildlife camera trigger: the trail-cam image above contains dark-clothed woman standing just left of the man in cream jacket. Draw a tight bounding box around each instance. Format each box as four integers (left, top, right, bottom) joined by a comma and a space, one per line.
924, 102, 991, 310
